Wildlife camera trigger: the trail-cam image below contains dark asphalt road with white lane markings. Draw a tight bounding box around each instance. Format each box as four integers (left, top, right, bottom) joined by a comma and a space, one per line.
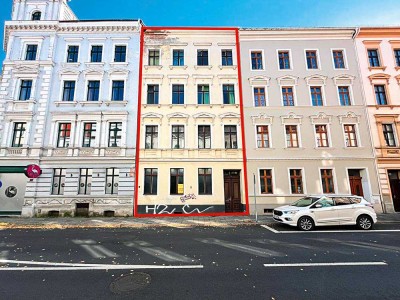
0, 223, 400, 300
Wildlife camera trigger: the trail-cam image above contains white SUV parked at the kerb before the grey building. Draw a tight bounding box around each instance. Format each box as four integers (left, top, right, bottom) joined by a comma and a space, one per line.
273, 195, 377, 231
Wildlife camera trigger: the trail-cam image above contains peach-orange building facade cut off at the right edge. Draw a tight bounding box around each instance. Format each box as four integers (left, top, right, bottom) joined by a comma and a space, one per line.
356, 27, 400, 212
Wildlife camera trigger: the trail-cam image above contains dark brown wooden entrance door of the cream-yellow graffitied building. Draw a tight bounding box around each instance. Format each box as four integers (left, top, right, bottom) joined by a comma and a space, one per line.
224, 170, 242, 212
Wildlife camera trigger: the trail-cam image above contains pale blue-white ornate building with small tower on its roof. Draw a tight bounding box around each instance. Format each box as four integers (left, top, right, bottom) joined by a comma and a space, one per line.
0, 0, 141, 216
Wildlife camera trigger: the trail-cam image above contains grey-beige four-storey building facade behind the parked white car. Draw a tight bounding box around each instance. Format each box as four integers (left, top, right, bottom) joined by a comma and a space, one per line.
240, 28, 381, 213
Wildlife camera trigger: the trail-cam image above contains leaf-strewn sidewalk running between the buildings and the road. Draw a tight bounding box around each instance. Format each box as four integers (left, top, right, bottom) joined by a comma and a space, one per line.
0, 213, 400, 230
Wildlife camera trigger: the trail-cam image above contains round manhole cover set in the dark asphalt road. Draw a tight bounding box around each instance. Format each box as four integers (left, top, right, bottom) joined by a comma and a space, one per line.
110, 272, 151, 294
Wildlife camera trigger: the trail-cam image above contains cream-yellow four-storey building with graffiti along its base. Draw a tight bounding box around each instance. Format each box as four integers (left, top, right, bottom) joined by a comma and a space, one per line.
136, 27, 245, 215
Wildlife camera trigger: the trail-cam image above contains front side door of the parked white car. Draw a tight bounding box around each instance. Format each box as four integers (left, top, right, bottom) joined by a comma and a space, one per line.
310, 198, 339, 226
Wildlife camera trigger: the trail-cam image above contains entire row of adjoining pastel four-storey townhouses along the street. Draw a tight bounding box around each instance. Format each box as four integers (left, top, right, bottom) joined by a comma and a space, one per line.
0, 0, 400, 216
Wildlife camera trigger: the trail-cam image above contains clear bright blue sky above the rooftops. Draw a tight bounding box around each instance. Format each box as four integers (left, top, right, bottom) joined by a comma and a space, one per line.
0, 0, 400, 61
